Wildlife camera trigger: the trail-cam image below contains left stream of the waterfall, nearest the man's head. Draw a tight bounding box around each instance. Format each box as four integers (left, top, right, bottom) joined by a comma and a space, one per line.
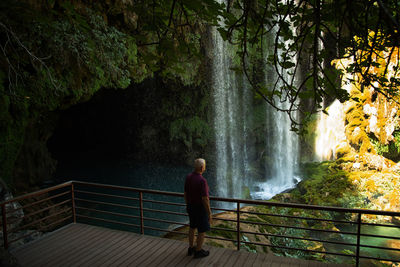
212, 25, 252, 198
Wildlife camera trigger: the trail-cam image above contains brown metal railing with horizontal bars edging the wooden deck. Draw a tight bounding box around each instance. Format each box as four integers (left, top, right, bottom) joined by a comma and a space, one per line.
0, 180, 400, 266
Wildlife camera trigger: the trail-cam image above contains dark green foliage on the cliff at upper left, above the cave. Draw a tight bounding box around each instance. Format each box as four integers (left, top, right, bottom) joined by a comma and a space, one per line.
0, 0, 142, 187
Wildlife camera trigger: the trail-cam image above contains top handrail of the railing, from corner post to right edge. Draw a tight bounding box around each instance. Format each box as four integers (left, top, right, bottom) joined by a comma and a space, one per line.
68, 180, 400, 217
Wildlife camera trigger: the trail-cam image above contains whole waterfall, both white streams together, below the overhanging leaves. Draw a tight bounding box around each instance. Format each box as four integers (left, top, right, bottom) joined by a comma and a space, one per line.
211, 2, 299, 199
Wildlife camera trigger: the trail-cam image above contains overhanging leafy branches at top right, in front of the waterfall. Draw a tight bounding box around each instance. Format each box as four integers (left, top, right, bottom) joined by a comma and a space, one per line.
214, 0, 400, 124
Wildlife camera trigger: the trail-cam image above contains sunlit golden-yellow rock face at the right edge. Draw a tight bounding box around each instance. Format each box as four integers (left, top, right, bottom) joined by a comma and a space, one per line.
326, 51, 400, 165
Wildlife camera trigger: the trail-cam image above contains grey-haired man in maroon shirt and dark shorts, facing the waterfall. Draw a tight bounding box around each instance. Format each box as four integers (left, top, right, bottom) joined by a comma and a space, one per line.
185, 159, 212, 258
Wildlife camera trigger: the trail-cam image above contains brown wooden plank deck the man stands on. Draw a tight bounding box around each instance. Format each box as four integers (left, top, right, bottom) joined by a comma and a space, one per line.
11, 224, 346, 267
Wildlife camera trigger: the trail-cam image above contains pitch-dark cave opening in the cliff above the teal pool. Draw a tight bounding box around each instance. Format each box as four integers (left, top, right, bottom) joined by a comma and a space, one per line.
47, 79, 184, 185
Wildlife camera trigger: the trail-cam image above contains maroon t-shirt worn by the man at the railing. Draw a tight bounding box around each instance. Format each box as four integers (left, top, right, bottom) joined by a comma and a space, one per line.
185, 172, 209, 204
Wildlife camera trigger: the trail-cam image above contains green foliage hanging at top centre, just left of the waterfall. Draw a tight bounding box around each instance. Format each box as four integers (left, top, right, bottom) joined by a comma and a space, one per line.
121, 0, 223, 85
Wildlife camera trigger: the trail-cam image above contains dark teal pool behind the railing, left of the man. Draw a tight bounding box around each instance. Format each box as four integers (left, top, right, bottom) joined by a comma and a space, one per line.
51, 159, 220, 235
